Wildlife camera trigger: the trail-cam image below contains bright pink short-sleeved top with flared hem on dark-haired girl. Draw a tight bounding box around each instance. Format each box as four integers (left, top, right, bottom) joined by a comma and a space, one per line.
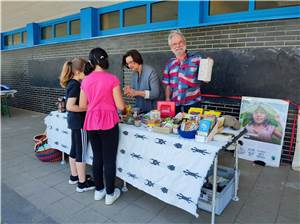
81, 71, 120, 130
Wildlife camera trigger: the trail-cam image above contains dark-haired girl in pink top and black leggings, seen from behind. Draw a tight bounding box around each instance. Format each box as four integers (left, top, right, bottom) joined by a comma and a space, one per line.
79, 48, 125, 205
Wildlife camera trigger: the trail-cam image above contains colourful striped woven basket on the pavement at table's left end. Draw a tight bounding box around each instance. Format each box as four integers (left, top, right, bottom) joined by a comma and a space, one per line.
33, 134, 62, 162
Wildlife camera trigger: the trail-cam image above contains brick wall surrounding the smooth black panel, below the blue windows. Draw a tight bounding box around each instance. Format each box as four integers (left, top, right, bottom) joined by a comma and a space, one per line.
1, 19, 300, 163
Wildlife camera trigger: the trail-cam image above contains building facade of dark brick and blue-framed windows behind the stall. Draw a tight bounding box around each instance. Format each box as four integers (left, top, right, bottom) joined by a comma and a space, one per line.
1, 1, 300, 163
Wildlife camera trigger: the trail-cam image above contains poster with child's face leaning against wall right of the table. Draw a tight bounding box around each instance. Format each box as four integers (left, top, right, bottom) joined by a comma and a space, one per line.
239, 97, 289, 167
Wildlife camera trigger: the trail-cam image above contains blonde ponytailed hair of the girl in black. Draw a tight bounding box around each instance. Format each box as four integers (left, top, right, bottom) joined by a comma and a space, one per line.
59, 58, 87, 88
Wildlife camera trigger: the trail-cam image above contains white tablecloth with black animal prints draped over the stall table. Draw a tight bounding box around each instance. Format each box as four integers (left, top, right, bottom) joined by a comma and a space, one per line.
45, 111, 225, 216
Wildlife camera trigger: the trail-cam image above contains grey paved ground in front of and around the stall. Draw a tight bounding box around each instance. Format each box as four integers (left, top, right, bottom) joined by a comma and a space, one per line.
1, 108, 300, 224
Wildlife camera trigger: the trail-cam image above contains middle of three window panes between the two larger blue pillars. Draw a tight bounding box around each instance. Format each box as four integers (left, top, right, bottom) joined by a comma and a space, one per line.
124, 5, 146, 26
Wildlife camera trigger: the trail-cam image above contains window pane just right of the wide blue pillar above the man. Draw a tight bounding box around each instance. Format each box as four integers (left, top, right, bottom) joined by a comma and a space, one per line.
209, 1, 249, 16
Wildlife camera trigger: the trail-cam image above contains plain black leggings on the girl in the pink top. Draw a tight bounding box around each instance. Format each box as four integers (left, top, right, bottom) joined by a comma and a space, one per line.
88, 124, 119, 194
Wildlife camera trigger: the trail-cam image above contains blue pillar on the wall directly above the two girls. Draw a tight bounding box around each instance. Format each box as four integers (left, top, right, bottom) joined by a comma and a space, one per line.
80, 7, 98, 39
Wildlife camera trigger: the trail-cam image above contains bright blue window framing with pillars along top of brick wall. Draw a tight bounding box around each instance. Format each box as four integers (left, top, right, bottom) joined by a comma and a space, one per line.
1, 0, 300, 50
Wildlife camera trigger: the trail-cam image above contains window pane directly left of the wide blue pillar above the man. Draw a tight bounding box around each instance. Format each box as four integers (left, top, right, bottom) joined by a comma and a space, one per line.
151, 1, 178, 23
